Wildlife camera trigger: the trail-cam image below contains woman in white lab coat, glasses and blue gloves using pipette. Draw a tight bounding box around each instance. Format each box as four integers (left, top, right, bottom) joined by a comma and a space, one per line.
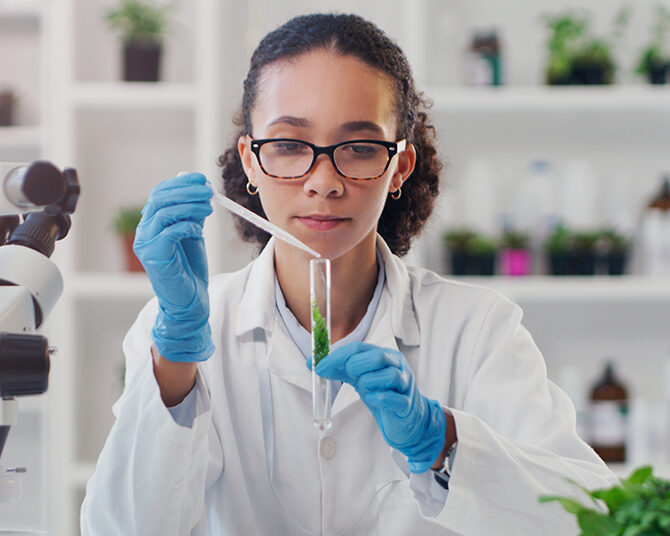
81, 15, 614, 536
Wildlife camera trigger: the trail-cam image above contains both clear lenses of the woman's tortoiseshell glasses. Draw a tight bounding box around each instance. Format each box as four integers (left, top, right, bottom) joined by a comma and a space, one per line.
259, 141, 388, 179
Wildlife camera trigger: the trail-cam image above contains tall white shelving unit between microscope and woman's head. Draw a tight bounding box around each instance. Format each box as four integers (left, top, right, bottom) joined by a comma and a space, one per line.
41, 0, 231, 536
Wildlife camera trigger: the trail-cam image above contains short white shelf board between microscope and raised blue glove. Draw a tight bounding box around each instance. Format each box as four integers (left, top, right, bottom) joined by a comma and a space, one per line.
64, 272, 153, 300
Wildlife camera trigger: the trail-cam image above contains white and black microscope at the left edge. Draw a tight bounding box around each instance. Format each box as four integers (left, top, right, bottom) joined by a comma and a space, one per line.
0, 160, 79, 502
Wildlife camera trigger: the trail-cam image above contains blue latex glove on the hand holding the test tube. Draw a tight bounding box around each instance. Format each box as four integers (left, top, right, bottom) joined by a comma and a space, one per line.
308, 342, 447, 473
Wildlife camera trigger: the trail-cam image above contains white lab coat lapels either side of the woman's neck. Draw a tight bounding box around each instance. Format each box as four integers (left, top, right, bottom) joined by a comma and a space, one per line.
235, 235, 420, 346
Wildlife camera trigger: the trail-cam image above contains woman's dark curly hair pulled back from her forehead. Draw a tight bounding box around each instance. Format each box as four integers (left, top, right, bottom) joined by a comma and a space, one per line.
218, 13, 442, 256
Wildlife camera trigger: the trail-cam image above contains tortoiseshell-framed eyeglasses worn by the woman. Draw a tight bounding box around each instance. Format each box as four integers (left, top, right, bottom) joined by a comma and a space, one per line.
251, 138, 407, 180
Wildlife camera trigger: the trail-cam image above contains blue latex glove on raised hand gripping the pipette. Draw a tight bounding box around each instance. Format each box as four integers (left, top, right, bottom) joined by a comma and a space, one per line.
133, 173, 214, 362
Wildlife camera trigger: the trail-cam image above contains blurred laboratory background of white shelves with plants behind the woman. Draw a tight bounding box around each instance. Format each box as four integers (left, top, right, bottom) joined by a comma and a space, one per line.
0, 0, 670, 536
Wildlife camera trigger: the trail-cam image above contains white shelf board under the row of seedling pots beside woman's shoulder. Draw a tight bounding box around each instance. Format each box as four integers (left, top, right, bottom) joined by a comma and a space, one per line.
447, 275, 670, 303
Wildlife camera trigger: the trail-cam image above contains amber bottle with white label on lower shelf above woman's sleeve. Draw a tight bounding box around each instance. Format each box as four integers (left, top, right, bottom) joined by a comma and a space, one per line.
591, 363, 628, 462
